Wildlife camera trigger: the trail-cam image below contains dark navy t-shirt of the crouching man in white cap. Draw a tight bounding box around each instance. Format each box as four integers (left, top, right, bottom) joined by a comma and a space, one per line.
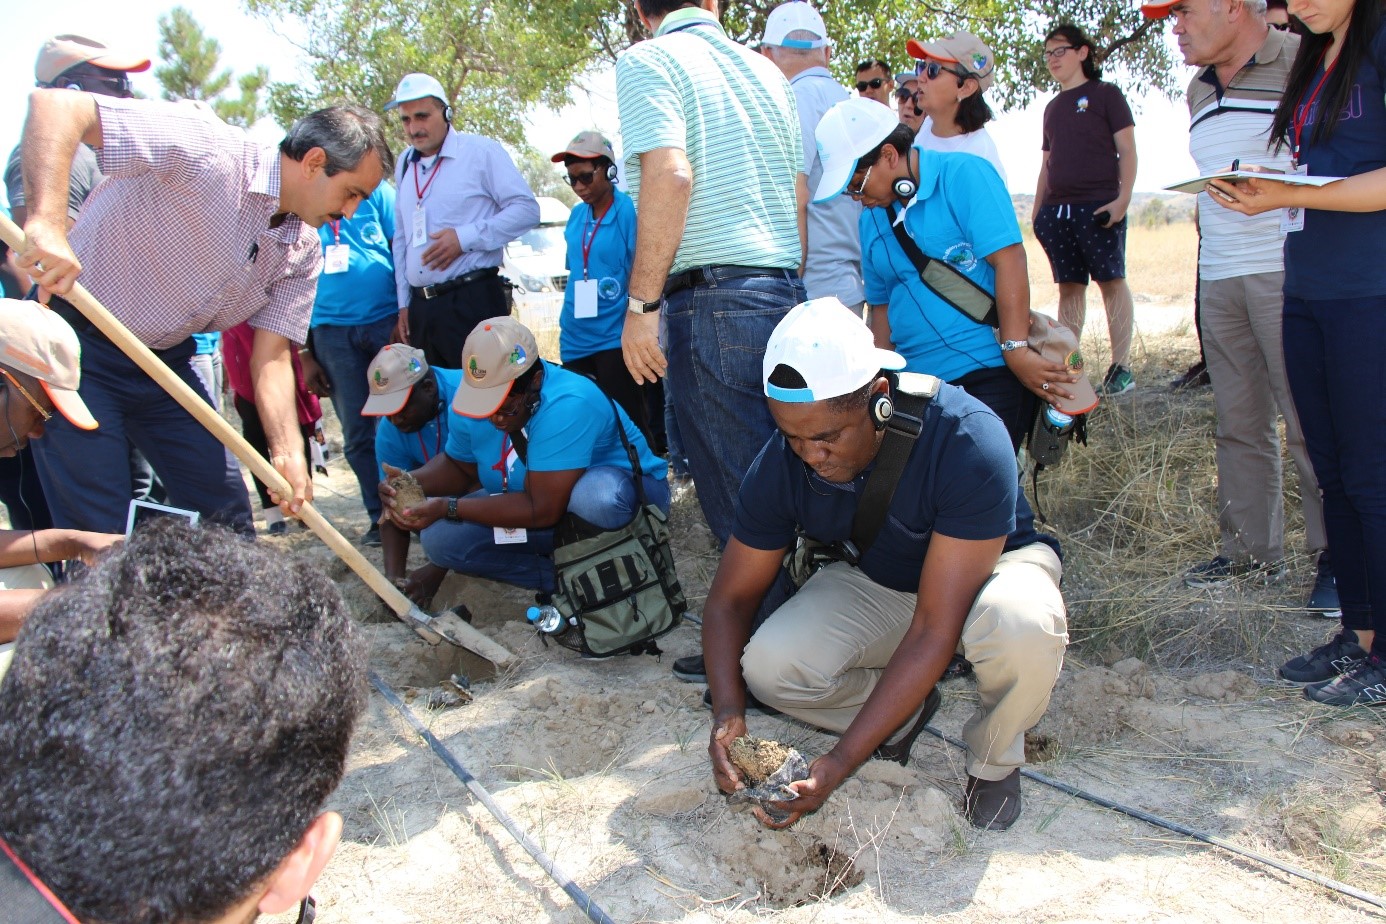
732, 385, 1059, 593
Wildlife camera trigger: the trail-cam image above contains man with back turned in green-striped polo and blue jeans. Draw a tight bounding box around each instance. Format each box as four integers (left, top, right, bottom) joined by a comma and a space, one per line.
615, 0, 808, 682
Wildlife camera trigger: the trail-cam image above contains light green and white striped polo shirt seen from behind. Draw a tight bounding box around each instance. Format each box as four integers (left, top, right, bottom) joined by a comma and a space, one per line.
615, 8, 804, 273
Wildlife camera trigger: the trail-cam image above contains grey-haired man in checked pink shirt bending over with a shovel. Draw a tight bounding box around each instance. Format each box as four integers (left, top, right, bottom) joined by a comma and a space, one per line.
19, 89, 394, 535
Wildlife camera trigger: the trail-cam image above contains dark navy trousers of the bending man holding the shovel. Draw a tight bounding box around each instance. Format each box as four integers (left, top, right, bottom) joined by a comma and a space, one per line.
33, 330, 255, 536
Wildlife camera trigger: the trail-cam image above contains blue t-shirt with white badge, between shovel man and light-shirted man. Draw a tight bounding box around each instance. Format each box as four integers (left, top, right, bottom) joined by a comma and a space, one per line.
312, 181, 399, 327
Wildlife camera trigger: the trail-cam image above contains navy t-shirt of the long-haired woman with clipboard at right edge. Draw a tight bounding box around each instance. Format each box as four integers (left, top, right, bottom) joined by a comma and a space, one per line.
1285, 25, 1386, 299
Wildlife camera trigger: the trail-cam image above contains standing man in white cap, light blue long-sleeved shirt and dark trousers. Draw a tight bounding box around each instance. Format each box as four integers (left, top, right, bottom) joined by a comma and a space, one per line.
385, 73, 539, 368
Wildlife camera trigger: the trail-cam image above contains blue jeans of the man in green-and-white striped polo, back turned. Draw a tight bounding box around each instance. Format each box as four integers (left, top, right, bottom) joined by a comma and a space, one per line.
665, 270, 804, 546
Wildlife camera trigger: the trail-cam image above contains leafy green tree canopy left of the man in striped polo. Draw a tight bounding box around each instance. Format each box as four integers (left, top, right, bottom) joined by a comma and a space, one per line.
247, 0, 626, 147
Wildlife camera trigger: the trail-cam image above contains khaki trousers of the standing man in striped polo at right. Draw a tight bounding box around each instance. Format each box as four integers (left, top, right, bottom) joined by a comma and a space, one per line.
1199, 273, 1328, 564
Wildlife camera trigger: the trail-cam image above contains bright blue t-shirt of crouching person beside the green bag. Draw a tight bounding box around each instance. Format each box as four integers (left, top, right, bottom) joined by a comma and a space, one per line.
445, 360, 668, 493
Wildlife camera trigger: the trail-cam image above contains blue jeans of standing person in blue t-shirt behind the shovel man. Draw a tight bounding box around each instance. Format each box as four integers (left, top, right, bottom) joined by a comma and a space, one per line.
313, 316, 399, 522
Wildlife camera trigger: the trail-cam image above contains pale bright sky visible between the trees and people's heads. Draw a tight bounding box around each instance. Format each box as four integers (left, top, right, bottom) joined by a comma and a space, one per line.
0, 0, 1198, 209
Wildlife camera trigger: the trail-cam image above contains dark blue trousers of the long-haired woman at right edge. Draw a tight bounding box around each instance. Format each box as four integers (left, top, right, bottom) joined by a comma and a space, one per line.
1283, 296, 1386, 657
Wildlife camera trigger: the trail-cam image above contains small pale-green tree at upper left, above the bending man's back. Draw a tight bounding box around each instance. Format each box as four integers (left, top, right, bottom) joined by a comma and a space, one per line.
154, 7, 269, 127
